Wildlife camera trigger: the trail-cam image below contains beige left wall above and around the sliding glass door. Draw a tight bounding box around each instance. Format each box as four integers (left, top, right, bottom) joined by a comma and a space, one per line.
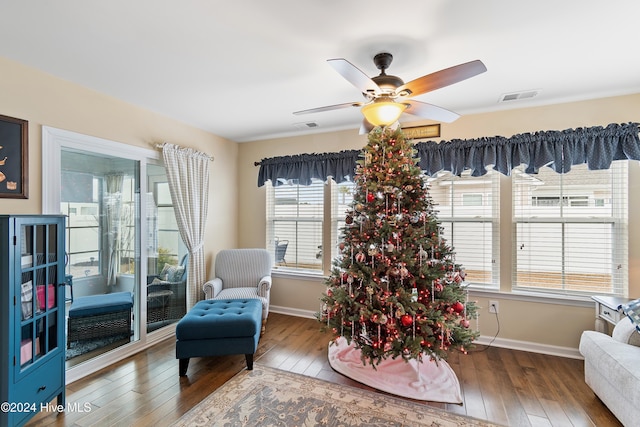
0, 58, 238, 274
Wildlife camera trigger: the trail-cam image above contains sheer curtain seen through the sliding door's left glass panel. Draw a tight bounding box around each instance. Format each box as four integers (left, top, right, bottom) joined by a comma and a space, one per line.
104, 174, 124, 286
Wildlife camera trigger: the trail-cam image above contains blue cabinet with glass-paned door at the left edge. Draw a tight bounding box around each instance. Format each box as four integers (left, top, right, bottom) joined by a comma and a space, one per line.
0, 215, 65, 427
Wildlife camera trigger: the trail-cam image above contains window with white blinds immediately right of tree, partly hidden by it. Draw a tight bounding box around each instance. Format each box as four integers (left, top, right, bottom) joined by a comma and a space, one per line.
427, 171, 500, 287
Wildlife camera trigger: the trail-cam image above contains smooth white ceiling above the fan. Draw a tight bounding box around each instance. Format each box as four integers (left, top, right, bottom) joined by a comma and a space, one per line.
0, 0, 640, 142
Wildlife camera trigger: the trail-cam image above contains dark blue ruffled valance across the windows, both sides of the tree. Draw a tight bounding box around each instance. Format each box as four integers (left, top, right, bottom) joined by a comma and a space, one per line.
258, 123, 640, 187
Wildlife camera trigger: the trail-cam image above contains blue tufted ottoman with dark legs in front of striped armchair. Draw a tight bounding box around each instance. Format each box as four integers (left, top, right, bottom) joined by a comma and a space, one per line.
176, 299, 262, 377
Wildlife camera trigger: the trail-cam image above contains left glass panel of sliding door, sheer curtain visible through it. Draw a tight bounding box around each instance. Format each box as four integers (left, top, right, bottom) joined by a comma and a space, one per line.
60, 148, 141, 366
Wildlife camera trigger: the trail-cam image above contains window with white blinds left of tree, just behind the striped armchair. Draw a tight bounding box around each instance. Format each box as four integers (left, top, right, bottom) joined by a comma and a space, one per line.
267, 179, 325, 273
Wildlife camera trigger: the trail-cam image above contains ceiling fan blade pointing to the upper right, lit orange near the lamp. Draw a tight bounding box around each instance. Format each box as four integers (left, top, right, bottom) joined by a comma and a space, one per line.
396, 60, 487, 97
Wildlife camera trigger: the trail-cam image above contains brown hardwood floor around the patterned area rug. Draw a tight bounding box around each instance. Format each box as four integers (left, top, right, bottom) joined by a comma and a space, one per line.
29, 313, 621, 427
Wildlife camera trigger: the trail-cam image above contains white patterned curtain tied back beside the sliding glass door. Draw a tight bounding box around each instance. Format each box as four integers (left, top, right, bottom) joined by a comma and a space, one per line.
162, 143, 211, 310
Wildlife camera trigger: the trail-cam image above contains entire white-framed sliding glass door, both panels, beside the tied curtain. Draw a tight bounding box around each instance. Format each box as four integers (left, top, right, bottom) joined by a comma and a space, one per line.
43, 127, 189, 382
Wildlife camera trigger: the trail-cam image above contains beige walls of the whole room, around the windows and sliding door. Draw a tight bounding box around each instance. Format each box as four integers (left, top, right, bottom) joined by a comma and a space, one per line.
0, 51, 640, 348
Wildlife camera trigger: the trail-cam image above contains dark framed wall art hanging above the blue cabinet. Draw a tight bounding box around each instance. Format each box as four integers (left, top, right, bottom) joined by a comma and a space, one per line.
0, 115, 29, 199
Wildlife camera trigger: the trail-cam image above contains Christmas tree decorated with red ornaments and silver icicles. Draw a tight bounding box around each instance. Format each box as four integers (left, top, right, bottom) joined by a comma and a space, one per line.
318, 127, 478, 367
